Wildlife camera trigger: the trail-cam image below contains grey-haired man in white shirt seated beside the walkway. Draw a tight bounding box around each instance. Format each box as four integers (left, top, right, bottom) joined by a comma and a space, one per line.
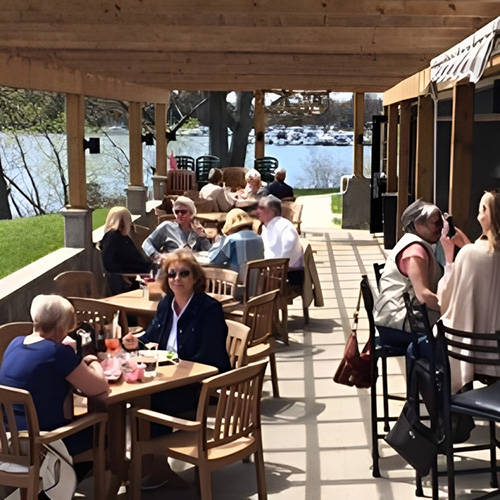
257, 194, 304, 285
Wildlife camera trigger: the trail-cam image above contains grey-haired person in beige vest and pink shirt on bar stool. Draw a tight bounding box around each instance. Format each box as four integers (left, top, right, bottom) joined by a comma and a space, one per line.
374, 200, 443, 347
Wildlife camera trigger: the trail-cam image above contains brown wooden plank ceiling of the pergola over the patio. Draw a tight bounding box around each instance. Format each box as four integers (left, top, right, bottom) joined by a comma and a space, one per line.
0, 0, 500, 102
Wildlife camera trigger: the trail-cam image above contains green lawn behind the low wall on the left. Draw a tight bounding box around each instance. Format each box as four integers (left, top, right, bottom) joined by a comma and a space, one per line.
0, 208, 109, 279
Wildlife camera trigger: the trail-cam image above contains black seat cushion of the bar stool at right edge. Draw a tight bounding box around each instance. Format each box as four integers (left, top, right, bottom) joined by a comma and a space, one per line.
451, 381, 500, 421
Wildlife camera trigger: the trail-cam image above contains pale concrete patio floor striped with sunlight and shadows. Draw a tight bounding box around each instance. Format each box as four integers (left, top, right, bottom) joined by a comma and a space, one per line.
6, 196, 489, 500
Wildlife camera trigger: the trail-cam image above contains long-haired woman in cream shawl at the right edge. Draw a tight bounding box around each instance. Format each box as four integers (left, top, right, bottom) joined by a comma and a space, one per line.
438, 190, 500, 392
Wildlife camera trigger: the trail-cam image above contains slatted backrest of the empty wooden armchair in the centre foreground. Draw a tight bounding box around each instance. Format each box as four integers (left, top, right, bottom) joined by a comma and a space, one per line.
197, 361, 267, 450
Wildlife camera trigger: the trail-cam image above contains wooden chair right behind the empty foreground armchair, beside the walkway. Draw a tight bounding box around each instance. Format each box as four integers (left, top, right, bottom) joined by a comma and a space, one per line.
243, 290, 280, 398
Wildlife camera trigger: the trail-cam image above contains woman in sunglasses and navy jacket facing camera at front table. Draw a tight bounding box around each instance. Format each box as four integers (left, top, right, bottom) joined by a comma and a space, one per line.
123, 249, 230, 489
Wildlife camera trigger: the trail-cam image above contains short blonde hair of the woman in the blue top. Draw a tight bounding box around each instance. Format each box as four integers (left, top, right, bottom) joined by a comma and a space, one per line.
30, 295, 76, 334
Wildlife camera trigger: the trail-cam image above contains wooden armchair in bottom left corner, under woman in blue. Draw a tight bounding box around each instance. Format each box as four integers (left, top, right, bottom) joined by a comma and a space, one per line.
0, 385, 107, 500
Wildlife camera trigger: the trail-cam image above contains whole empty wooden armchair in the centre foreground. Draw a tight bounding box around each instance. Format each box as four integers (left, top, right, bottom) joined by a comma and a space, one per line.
129, 362, 267, 500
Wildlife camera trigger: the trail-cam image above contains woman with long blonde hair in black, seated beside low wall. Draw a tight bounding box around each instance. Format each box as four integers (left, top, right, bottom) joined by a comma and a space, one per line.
100, 207, 151, 295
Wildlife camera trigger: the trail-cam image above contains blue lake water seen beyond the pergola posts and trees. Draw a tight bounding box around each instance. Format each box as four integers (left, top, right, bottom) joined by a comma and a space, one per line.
0, 133, 371, 216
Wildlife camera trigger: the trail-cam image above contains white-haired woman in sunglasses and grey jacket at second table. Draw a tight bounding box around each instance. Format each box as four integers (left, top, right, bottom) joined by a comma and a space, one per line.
142, 196, 210, 263
